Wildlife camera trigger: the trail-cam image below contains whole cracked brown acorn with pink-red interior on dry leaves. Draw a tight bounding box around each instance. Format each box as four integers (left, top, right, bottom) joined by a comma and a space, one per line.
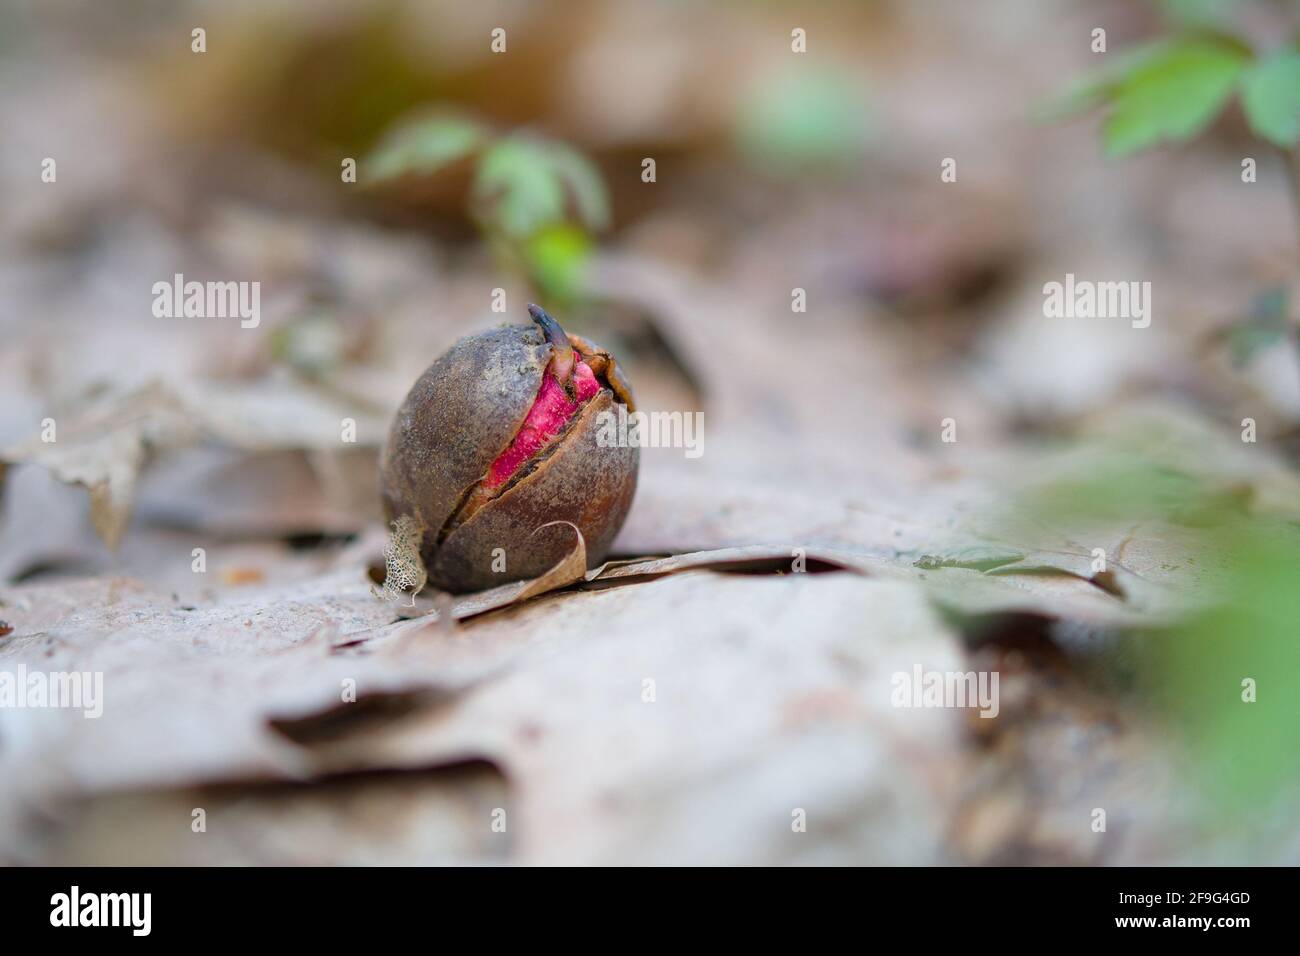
380, 306, 640, 593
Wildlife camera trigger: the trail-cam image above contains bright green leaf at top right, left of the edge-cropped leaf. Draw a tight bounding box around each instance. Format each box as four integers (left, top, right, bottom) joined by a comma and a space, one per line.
1102, 39, 1248, 157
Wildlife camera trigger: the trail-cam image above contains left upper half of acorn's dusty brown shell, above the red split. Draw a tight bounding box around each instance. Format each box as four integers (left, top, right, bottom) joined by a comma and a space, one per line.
380, 325, 551, 553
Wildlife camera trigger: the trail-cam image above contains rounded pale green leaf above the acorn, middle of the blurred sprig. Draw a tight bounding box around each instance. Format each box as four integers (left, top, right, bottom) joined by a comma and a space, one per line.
473, 135, 610, 239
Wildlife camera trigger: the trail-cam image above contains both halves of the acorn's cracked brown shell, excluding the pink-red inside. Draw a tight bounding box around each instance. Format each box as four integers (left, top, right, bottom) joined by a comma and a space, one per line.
381, 325, 640, 593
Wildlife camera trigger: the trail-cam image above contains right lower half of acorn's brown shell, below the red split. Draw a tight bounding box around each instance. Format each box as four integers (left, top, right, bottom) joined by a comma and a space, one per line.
425, 389, 640, 593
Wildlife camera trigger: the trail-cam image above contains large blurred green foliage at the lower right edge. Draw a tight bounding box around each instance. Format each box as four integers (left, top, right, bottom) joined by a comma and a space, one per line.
995, 419, 1300, 829
